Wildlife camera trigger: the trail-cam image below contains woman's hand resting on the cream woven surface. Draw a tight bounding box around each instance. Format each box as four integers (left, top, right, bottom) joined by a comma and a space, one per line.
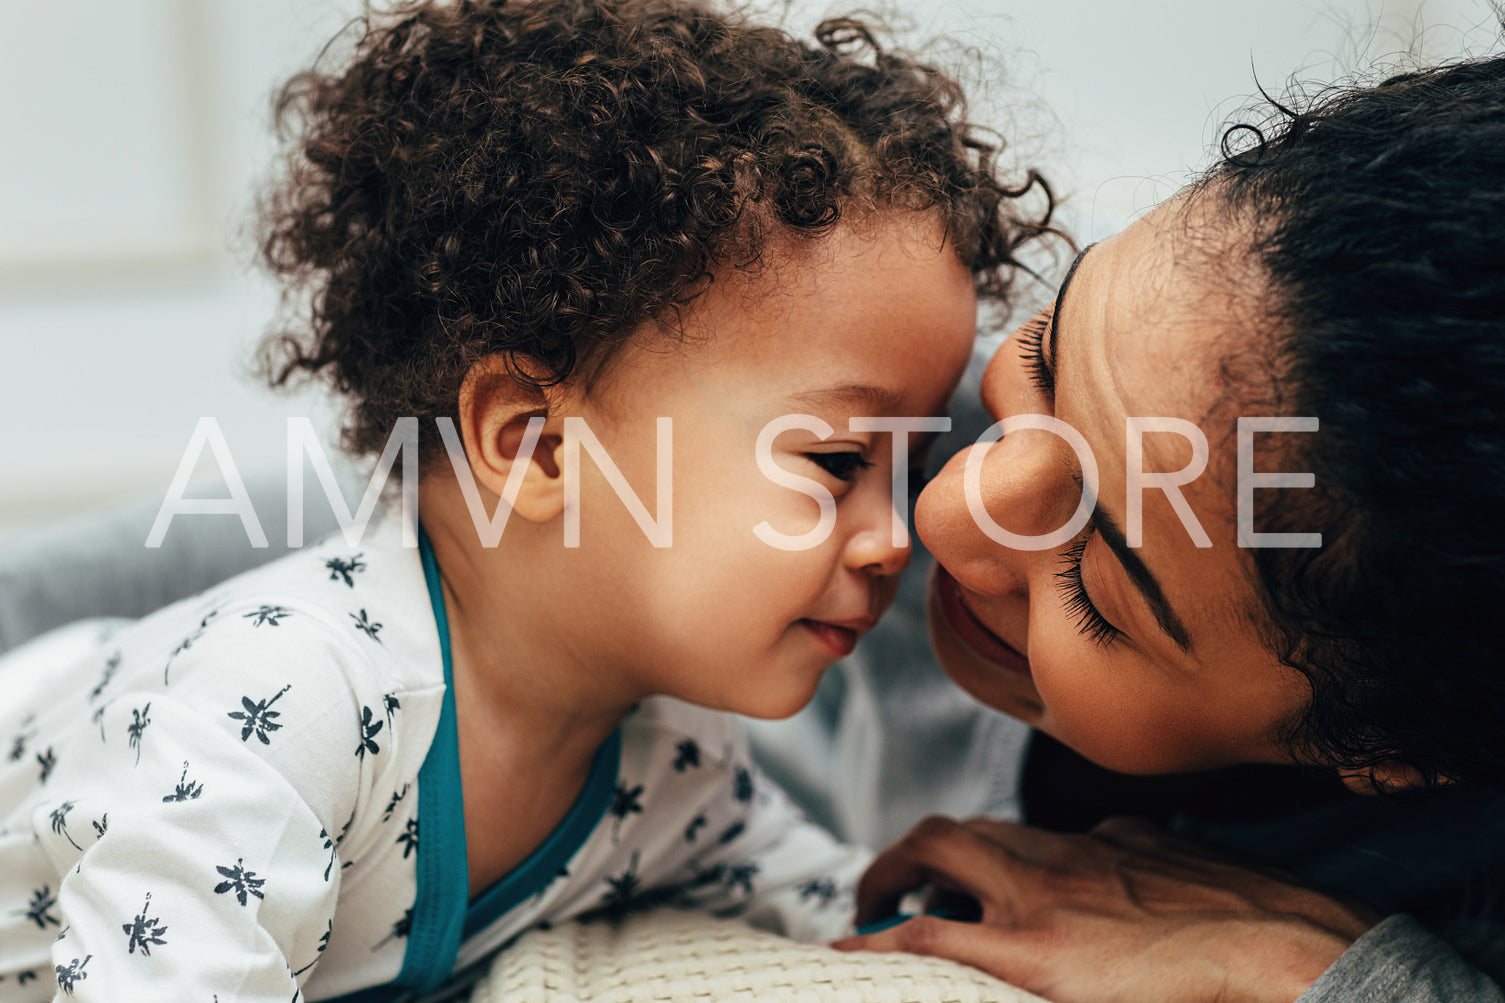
834, 818, 1380, 1003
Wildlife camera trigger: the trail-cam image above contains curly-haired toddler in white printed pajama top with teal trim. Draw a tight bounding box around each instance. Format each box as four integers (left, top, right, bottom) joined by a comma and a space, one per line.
0, 0, 1043, 1003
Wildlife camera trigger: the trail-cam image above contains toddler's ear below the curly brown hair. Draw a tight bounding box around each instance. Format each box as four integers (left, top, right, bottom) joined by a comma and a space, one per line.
459, 355, 564, 523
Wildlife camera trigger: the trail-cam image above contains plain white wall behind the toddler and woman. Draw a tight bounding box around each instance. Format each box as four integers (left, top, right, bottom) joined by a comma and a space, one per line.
0, 0, 1496, 539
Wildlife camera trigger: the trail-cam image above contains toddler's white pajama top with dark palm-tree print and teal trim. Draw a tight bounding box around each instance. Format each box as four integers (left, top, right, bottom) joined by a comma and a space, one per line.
0, 518, 867, 1003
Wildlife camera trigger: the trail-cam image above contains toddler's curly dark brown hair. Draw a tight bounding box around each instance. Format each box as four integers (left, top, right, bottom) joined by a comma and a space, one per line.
262, 0, 1054, 461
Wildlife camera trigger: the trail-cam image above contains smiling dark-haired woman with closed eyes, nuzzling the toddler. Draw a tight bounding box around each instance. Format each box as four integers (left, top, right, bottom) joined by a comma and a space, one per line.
843, 52, 1505, 1003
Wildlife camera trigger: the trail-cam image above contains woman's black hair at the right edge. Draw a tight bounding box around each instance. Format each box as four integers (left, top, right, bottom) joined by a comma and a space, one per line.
1201, 57, 1505, 785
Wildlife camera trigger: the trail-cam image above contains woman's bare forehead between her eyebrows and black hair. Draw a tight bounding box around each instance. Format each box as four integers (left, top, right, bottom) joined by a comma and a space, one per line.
1057, 206, 1260, 608
